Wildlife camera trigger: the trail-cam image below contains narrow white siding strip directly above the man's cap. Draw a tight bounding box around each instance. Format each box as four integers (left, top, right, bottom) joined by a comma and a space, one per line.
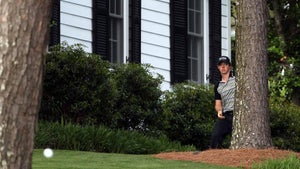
221, 0, 231, 57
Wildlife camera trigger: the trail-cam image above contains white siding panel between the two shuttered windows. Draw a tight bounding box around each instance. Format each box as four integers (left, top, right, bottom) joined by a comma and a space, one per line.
141, 0, 170, 90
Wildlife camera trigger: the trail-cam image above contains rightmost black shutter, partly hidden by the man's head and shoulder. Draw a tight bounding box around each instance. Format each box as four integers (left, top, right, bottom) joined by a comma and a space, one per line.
209, 0, 222, 84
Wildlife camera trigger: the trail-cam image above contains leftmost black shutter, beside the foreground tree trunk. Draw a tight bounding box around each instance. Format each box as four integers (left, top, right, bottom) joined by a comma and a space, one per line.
49, 0, 60, 46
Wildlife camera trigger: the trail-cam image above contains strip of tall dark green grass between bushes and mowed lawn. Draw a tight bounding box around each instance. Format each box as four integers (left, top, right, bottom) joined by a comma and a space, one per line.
35, 122, 194, 154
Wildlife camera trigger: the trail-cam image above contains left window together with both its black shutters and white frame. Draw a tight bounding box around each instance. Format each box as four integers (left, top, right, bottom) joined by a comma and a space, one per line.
92, 0, 141, 63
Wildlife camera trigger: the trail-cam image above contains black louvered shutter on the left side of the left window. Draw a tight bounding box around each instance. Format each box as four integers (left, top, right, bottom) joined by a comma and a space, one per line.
93, 0, 110, 60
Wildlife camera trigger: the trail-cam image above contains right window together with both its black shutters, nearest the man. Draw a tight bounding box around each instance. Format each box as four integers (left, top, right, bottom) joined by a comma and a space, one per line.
170, 0, 221, 84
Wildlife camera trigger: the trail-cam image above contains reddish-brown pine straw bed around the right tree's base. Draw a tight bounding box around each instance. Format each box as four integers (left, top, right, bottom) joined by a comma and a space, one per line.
154, 148, 300, 168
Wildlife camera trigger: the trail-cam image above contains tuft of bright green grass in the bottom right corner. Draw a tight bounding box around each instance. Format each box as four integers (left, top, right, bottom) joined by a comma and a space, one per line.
252, 155, 300, 169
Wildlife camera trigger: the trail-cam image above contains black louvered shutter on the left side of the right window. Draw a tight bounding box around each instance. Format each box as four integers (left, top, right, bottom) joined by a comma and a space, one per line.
170, 0, 188, 84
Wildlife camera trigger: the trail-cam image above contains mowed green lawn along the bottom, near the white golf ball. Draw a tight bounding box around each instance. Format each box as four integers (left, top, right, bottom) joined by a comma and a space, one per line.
32, 149, 237, 169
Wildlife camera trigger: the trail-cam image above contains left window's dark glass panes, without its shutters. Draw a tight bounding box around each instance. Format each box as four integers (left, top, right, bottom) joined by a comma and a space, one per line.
109, 0, 124, 63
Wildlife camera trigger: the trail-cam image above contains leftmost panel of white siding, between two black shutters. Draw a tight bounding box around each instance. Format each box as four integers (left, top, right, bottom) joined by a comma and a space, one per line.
60, 0, 92, 52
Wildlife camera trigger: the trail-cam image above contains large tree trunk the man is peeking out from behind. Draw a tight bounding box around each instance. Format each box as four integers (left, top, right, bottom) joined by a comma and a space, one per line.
231, 0, 272, 149
